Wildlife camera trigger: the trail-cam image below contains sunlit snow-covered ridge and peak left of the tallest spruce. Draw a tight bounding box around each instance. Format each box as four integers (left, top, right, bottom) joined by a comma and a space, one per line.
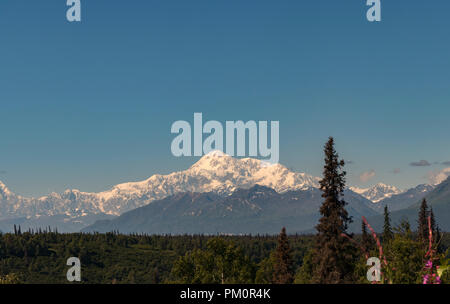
0, 151, 319, 219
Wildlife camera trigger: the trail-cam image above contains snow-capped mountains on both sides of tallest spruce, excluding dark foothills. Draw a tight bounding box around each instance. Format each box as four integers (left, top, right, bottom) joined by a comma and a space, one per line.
0, 151, 442, 232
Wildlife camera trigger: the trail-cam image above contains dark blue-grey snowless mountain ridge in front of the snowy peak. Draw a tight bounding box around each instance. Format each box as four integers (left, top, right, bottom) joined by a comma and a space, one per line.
83, 185, 377, 234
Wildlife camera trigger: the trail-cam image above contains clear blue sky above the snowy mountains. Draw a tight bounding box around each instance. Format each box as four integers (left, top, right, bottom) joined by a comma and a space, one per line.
0, 0, 450, 196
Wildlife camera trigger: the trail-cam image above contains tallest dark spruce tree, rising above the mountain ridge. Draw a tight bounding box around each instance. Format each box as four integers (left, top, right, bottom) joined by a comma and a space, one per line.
313, 137, 355, 284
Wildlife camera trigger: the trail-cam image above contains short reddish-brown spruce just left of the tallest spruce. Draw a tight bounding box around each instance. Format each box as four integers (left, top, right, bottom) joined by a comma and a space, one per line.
272, 227, 295, 284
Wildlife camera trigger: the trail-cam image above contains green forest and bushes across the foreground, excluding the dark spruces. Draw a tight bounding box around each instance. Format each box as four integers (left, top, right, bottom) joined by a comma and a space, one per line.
0, 229, 450, 284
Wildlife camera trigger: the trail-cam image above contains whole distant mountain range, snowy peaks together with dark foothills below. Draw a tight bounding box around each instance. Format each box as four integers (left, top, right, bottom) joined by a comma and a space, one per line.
0, 151, 444, 233
